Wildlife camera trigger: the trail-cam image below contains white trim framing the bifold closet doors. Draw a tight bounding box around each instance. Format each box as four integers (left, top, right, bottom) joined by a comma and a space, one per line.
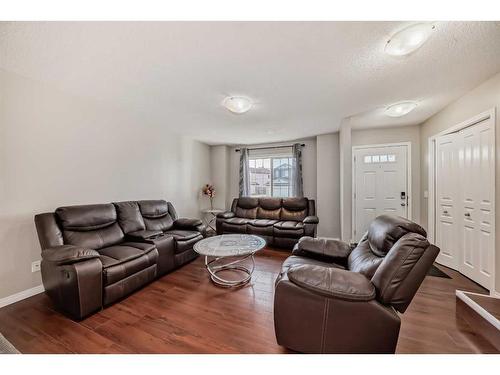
427, 107, 497, 295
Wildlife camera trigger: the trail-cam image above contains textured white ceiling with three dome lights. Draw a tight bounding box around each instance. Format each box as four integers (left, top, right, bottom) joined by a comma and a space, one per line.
0, 22, 500, 144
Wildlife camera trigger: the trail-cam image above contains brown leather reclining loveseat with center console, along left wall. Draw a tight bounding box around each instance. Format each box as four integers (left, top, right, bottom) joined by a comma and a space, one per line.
35, 200, 204, 320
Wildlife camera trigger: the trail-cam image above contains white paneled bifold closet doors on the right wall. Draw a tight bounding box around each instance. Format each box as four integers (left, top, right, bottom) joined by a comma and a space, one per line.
435, 118, 495, 289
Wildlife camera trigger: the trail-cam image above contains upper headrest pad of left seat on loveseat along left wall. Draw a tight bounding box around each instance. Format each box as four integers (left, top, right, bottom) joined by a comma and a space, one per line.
56, 204, 116, 231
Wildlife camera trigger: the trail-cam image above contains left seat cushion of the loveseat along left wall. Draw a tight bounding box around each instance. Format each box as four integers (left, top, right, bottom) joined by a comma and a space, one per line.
98, 242, 158, 285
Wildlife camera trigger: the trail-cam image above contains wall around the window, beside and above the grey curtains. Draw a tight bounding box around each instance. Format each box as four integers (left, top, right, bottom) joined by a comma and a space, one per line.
228, 138, 316, 204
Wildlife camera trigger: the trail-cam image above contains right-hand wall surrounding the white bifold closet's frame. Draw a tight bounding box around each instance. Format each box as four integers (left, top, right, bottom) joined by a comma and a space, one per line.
420, 73, 500, 291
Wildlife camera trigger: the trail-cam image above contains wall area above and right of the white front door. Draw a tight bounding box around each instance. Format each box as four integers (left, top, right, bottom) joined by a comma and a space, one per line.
352, 125, 422, 223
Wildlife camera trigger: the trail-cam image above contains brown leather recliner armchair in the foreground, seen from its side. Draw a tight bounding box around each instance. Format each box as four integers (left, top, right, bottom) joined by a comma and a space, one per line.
274, 215, 439, 353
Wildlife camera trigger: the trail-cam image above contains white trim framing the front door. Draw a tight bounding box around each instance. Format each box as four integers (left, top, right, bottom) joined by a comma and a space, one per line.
351, 141, 413, 238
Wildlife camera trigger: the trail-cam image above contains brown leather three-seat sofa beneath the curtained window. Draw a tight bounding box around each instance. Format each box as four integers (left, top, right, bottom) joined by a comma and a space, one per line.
216, 197, 319, 249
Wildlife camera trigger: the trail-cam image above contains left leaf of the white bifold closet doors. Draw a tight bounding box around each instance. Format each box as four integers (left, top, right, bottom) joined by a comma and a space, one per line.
435, 134, 461, 269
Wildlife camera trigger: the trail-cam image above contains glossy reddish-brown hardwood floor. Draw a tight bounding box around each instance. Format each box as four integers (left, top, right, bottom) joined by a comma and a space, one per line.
0, 249, 496, 353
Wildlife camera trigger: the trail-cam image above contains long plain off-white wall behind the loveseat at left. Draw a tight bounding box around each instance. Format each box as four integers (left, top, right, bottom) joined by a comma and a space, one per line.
0, 70, 210, 298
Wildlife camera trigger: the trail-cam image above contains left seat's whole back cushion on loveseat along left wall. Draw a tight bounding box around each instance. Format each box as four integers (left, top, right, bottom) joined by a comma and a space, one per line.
56, 204, 124, 249
